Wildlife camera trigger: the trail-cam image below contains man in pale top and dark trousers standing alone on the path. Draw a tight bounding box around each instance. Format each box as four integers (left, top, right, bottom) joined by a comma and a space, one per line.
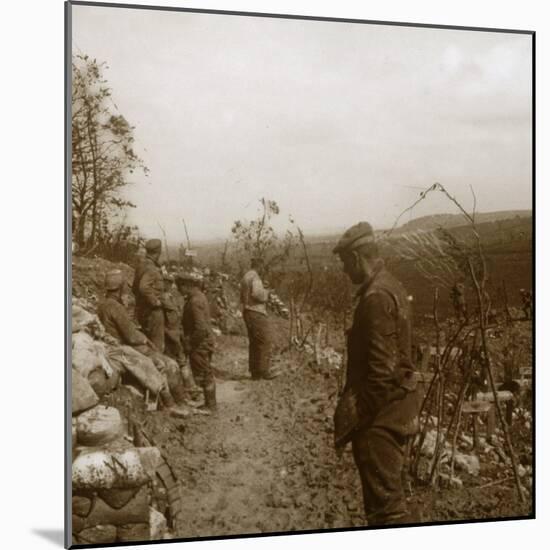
241, 257, 280, 380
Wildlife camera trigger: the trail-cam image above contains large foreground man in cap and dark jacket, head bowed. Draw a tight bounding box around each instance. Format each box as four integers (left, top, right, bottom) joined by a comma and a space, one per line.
333, 222, 418, 525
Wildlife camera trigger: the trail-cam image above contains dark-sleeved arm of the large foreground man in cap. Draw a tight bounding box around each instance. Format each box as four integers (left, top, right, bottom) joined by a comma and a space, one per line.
357, 291, 398, 414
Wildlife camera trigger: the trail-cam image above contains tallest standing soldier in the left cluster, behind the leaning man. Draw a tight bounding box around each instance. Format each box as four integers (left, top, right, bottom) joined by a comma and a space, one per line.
132, 239, 164, 353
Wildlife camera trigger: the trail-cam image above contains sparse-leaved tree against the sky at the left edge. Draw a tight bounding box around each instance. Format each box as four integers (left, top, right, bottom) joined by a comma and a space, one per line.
72, 55, 148, 249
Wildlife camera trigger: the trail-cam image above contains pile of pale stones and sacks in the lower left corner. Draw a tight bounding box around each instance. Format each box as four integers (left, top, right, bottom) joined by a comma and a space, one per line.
71, 299, 167, 544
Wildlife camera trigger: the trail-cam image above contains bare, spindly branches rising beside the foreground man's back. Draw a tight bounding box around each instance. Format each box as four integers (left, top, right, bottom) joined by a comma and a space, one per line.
392, 183, 525, 503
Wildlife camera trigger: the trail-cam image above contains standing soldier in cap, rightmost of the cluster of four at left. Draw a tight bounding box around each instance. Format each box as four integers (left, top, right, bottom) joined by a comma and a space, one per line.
176, 272, 217, 412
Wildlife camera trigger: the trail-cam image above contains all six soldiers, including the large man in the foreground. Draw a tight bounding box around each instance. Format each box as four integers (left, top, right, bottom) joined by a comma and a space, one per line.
98, 222, 432, 525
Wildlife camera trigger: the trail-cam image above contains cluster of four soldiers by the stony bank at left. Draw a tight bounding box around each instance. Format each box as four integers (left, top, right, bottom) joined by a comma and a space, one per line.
98, 239, 217, 416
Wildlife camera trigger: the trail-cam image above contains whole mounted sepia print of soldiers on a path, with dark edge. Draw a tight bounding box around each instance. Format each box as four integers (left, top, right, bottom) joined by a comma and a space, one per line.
65, 1, 535, 547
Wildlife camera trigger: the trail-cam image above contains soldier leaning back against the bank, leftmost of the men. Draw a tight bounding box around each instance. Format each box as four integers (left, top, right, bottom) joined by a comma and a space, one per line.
97, 269, 192, 416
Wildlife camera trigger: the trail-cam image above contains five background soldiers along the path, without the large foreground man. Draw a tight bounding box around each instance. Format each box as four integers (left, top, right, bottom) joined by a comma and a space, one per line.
98, 239, 280, 416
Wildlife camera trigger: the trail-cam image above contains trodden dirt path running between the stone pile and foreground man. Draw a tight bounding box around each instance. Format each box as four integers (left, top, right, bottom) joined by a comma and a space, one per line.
151, 338, 362, 537
